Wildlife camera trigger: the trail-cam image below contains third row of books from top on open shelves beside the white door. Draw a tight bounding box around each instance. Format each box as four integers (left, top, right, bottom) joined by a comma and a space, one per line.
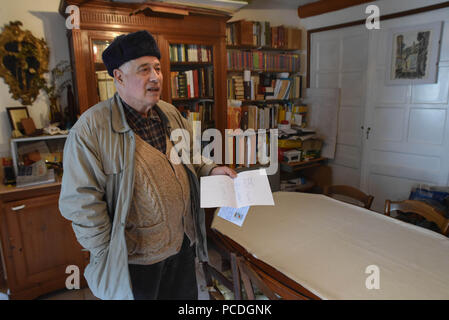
227, 74, 302, 100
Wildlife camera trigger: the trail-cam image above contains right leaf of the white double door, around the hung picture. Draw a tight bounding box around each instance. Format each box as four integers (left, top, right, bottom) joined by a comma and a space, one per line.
361, 9, 449, 211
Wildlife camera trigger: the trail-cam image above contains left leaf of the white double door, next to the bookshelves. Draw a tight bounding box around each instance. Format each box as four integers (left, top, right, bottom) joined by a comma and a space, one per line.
310, 26, 368, 188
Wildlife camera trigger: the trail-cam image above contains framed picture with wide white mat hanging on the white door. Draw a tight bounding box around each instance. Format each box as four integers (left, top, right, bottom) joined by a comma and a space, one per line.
386, 22, 442, 85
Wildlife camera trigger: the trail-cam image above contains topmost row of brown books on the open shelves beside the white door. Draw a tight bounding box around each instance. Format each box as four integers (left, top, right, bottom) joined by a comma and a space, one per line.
226, 20, 301, 50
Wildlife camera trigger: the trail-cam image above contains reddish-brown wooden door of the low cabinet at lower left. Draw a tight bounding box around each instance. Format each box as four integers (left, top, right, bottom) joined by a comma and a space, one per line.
4, 194, 85, 297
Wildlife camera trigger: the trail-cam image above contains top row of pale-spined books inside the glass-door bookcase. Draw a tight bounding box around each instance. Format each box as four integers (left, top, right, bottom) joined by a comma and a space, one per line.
170, 44, 212, 63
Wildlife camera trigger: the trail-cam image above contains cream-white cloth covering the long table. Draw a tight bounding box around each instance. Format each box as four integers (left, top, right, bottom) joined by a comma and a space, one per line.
212, 192, 449, 299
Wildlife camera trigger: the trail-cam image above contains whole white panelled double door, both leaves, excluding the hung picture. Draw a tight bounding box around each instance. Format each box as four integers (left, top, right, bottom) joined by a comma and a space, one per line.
310, 9, 449, 212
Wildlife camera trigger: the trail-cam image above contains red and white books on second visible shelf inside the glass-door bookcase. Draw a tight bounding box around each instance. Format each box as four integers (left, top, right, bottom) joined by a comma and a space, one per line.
170, 67, 214, 99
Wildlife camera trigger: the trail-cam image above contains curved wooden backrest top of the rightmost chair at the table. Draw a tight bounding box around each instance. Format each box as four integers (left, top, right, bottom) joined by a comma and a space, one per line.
384, 200, 449, 235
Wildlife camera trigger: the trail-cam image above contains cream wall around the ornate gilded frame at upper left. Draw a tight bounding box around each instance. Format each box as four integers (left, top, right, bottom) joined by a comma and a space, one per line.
0, 0, 70, 156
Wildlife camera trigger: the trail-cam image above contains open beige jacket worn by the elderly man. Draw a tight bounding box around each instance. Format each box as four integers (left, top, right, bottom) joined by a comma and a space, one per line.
59, 94, 216, 299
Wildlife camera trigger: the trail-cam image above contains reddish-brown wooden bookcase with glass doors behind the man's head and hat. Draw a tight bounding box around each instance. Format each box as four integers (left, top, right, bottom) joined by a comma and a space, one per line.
59, 0, 230, 132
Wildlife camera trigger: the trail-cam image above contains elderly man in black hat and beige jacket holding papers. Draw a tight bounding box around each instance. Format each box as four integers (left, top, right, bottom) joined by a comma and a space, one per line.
59, 31, 236, 299
